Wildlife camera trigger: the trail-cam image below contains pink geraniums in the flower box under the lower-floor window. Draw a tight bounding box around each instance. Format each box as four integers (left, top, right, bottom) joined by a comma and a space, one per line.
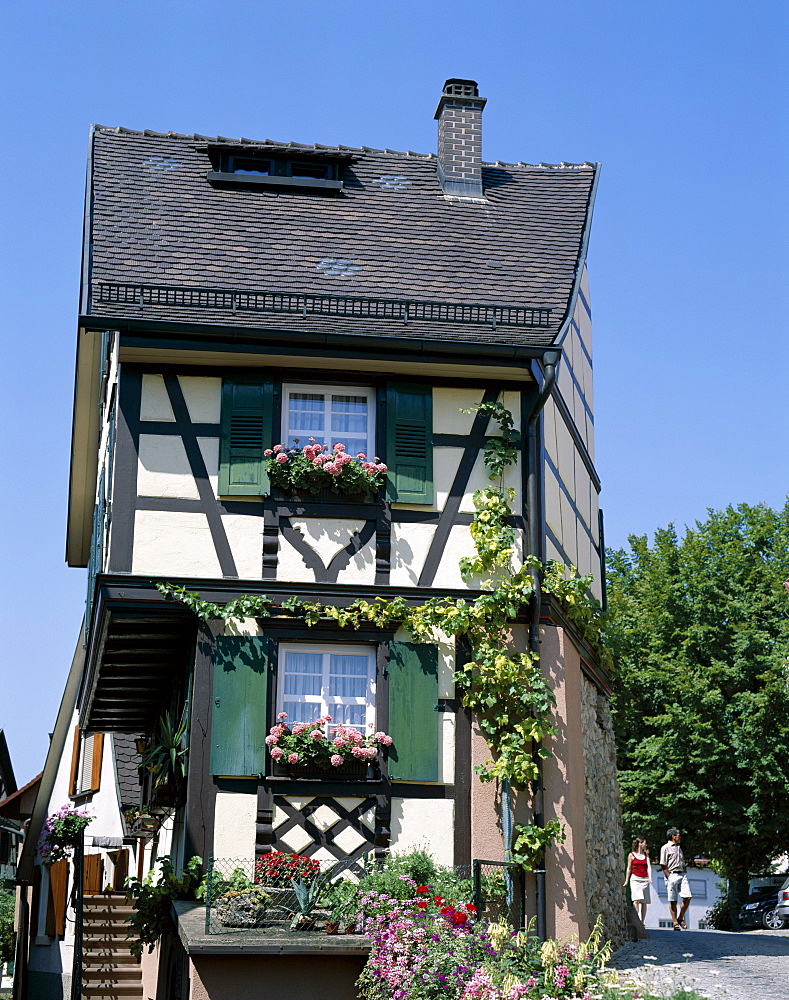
266, 712, 392, 777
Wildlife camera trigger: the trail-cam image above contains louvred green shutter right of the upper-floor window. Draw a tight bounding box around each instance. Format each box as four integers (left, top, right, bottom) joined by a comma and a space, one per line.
386, 382, 433, 503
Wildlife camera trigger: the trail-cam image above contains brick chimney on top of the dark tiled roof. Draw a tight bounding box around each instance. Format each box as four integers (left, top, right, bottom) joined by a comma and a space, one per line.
434, 80, 486, 198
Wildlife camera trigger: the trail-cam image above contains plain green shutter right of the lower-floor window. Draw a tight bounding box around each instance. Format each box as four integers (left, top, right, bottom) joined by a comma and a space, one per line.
389, 642, 439, 781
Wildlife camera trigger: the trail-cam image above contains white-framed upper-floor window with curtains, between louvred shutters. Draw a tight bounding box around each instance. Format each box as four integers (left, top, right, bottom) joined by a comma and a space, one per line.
282, 385, 375, 457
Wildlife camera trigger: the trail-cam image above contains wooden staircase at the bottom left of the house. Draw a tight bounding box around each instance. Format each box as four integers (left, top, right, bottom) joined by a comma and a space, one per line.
82, 893, 143, 1000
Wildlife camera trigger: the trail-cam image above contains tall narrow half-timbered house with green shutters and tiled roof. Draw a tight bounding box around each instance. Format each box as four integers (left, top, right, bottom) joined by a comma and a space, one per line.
30, 80, 619, 995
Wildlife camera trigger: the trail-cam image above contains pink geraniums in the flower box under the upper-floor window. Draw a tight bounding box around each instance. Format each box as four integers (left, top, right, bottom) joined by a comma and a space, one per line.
263, 438, 387, 499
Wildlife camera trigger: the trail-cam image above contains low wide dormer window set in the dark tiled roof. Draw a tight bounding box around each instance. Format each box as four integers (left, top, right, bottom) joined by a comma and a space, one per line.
208, 150, 343, 191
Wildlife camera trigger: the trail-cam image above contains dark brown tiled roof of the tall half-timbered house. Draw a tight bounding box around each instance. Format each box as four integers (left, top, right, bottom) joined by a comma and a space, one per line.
90, 127, 595, 345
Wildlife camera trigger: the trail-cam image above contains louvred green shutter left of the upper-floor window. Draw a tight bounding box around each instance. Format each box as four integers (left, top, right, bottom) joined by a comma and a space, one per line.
219, 380, 276, 496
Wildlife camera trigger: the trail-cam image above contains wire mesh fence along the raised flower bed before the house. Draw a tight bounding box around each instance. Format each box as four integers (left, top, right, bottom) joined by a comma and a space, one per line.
204, 852, 526, 934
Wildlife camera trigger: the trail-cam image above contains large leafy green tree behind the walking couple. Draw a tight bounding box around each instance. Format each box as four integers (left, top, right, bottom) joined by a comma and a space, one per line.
608, 502, 789, 919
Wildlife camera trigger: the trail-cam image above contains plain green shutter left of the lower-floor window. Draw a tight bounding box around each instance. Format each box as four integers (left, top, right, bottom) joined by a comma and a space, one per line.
211, 635, 269, 777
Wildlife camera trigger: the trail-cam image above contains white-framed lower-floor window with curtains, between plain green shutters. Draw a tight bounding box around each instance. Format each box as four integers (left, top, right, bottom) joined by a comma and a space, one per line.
277, 643, 375, 736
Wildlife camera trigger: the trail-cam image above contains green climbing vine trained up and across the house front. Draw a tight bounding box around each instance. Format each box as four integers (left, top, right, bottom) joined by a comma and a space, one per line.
157, 402, 600, 812
